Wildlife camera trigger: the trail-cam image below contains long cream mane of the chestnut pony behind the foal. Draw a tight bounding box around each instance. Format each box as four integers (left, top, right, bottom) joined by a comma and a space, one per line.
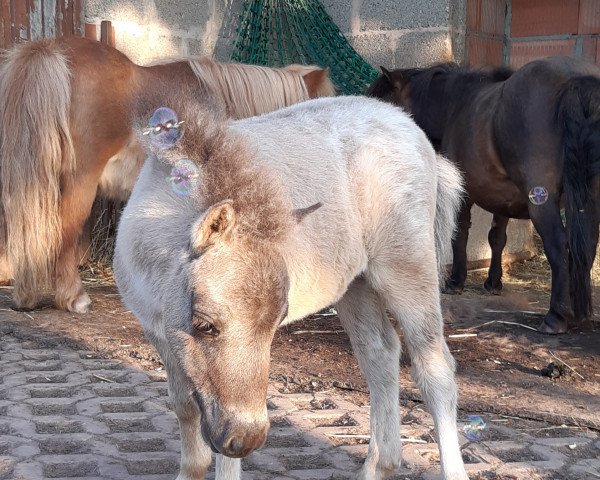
187, 58, 335, 119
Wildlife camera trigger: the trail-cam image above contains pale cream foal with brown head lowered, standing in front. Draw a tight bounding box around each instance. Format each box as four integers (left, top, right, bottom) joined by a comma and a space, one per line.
114, 97, 467, 480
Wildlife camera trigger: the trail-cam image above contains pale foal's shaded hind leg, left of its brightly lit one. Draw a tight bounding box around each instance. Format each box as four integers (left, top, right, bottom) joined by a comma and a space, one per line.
336, 278, 402, 480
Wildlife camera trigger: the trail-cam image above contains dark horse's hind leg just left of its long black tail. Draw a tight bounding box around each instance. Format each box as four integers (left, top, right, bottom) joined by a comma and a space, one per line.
529, 199, 573, 334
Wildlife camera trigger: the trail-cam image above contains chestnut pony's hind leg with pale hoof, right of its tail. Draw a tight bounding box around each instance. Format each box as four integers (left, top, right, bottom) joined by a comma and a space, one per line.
55, 172, 98, 313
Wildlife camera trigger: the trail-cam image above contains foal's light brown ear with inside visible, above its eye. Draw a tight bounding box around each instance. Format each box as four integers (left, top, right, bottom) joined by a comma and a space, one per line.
192, 200, 236, 254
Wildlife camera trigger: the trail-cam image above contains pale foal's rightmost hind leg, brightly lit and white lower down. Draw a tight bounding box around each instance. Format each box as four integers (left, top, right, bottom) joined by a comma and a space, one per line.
368, 258, 468, 480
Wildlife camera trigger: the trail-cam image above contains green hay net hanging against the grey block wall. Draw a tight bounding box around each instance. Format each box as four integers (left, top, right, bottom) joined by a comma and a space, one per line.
231, 0, 379, 95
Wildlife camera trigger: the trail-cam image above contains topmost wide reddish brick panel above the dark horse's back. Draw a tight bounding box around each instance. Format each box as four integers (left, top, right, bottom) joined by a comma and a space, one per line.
511, 0, 580, 37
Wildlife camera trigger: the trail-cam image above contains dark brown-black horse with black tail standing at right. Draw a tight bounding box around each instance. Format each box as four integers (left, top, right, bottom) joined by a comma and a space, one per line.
367, 57, 600, 333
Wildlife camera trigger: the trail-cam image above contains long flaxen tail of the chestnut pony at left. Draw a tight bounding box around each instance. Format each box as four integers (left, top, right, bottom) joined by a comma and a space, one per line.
0, 40, 75, 308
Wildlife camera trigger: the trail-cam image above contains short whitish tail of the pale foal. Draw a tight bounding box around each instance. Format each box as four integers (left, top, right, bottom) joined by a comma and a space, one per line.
435, 155, 465, 283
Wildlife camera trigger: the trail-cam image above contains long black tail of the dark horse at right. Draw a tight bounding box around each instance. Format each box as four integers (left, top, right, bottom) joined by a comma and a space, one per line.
557, 76, 600, 319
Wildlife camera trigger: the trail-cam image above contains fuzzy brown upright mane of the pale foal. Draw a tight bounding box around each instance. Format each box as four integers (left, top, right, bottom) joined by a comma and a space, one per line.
148, 103, 294, 241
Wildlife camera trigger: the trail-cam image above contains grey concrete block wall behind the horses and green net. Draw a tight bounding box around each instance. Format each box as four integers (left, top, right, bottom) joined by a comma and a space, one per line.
85, 0, 531, 262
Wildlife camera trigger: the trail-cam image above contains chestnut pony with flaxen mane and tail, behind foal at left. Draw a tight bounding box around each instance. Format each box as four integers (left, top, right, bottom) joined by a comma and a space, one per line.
0, 37, 334, 313
